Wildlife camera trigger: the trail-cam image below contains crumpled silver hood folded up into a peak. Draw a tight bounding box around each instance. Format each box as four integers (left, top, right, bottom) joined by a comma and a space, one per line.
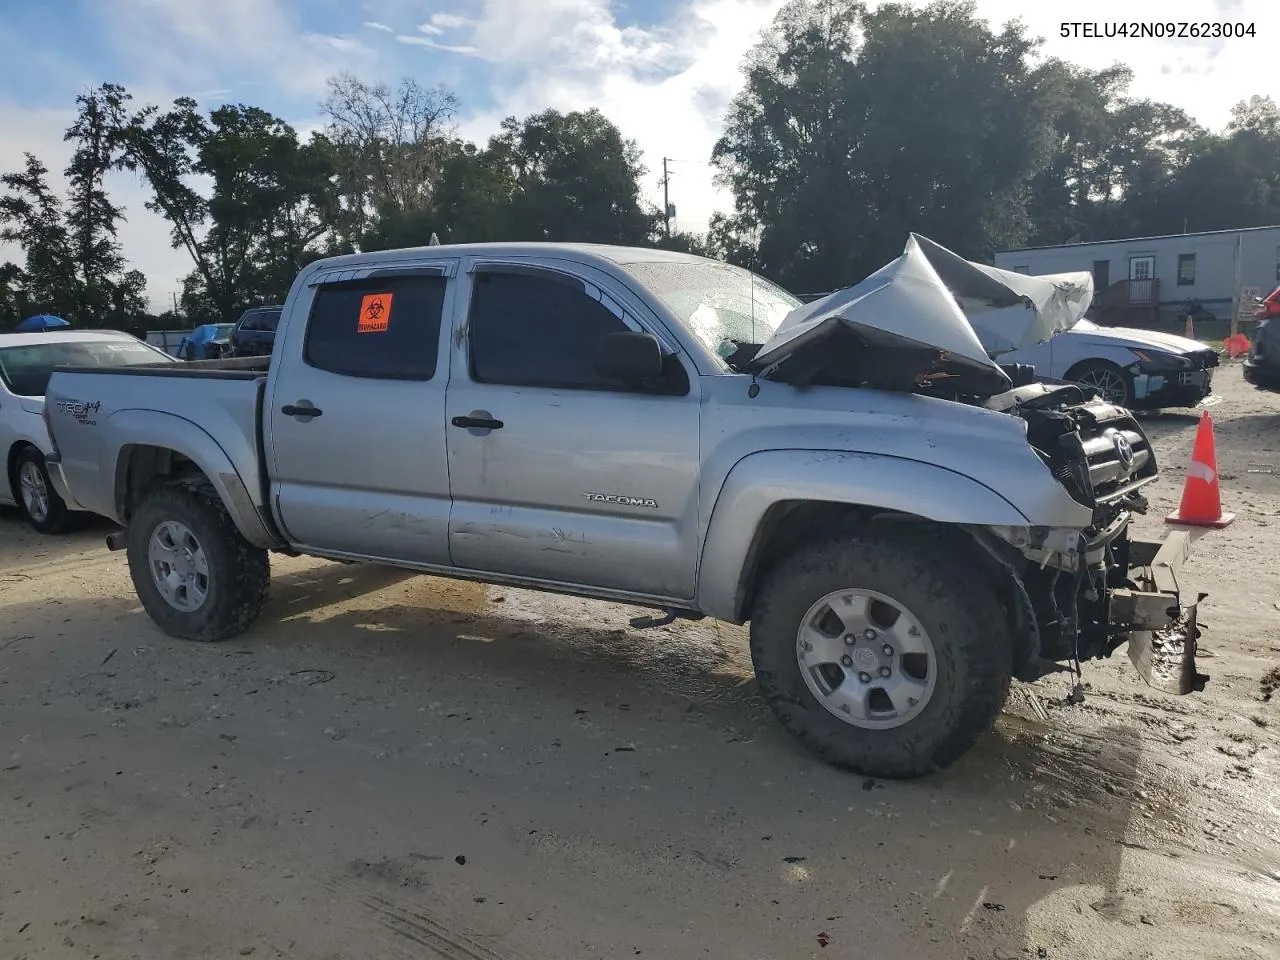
748, 233, 1093, 396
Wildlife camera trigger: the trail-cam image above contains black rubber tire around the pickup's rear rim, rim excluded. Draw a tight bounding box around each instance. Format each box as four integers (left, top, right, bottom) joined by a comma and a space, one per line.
127, 483, 271, 641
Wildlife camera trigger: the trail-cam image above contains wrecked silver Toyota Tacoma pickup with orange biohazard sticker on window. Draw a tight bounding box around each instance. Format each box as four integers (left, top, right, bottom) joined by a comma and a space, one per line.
37, 243, 1206, 777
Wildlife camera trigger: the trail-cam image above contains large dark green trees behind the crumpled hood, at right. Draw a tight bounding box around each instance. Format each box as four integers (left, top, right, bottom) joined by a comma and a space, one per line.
708, 0, 1280, 291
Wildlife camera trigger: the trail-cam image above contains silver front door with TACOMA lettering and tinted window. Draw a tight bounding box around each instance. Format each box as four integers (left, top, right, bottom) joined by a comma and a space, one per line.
445, 265, 699, 600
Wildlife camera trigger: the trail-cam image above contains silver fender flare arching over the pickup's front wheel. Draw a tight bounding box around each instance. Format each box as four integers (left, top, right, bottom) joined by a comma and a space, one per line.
696, 449, 1030, 623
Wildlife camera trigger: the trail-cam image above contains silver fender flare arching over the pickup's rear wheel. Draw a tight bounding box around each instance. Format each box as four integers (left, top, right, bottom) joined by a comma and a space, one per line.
110, 410, 278, 548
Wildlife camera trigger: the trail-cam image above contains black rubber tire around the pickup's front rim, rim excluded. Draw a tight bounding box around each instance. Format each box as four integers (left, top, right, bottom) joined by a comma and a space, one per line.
750, 530, 1014, 778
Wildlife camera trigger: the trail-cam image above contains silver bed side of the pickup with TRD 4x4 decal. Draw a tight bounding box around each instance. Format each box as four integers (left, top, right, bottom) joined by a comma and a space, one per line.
46, 357, 271, 522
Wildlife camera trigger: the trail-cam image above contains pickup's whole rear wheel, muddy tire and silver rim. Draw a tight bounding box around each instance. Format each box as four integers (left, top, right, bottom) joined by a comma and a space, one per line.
128, 484, 271, 641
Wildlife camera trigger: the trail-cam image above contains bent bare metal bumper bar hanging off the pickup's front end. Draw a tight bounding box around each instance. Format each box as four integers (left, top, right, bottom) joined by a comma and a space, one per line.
1108, 530, 1208, 695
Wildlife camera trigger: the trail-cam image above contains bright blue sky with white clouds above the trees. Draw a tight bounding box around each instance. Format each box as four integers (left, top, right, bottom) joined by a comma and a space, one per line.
0, 0, 1280, 303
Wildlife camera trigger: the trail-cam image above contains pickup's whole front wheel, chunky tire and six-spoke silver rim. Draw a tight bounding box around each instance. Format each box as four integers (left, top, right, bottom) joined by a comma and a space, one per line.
751, 531, 1014, 778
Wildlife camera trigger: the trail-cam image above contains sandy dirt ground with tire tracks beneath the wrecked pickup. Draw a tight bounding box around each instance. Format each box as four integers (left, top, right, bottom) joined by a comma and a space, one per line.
0, 367, 1280, 960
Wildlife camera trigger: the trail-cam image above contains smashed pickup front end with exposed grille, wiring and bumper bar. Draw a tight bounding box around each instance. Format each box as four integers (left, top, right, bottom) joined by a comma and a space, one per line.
983, 384, 1208, 694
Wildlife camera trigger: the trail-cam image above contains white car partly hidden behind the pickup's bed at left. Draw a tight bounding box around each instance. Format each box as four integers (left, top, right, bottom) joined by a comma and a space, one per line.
0, 329, 178, 534
